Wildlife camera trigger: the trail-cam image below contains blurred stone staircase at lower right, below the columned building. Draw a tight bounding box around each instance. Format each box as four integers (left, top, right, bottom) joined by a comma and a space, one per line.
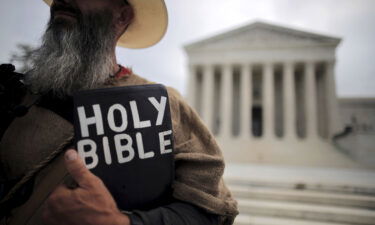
225, 163, 375, 225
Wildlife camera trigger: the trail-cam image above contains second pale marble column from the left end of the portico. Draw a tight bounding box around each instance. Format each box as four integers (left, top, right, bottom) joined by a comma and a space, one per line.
202, 65, 214, 131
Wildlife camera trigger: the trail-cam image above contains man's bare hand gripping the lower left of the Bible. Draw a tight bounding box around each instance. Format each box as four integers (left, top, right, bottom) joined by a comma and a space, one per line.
43, 150, 130, 225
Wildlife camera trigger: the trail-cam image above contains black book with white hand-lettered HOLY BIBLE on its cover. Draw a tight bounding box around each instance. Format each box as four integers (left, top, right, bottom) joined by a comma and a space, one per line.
74, 84, 174, 210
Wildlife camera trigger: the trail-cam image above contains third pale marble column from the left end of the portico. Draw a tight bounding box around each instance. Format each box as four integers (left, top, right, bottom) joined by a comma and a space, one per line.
219, 64, 233, 138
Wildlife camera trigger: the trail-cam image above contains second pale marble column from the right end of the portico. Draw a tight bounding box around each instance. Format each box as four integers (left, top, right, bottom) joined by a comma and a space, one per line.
305, 62, 318, 139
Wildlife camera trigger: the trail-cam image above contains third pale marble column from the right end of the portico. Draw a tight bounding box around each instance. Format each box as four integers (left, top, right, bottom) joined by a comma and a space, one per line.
283, 62, 297, 138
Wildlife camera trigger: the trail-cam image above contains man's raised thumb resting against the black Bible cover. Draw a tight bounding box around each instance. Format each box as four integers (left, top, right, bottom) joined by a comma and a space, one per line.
65, 149, 98, 188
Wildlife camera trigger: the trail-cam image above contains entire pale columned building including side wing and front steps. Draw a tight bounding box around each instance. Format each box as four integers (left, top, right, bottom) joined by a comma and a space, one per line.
185, 22, 375, 225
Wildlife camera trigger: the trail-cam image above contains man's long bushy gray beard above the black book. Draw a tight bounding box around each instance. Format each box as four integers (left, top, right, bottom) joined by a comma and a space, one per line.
26, 10, 115, 97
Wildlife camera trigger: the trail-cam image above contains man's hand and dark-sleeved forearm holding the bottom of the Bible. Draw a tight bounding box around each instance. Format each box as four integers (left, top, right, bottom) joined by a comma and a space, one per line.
43, 150, 219, 225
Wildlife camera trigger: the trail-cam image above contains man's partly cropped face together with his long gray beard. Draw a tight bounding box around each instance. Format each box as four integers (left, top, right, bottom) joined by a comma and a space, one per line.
28, 0, 129, 96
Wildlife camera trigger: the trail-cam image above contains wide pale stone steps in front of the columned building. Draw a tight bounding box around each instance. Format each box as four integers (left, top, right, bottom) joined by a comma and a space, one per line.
224, 165, 375, 225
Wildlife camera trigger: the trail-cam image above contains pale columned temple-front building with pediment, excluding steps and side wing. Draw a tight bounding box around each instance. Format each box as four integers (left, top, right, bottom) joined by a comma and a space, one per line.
185, 22, 359, 167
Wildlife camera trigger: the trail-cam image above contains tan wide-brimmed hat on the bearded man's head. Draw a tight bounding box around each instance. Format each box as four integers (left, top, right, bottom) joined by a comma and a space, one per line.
44, 0, 168, 48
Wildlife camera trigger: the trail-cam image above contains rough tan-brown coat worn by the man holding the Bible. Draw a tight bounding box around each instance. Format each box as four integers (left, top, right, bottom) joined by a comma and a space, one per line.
0, 74, 238, 225
